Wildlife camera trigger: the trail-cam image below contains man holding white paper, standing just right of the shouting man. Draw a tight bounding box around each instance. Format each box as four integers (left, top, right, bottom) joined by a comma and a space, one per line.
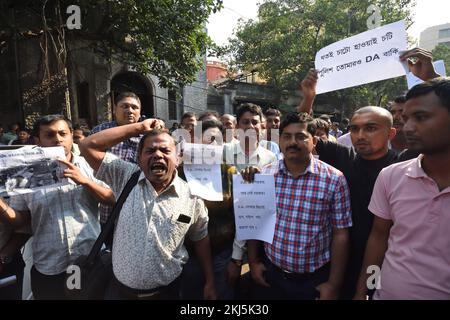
178, 120, 237, 300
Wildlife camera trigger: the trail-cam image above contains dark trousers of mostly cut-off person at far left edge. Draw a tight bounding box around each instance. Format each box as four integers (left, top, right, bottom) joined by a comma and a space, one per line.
0, 251, 25, 300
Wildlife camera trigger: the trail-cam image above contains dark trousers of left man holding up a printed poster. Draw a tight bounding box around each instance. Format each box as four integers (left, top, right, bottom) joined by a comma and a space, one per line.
31, 266, 66, 300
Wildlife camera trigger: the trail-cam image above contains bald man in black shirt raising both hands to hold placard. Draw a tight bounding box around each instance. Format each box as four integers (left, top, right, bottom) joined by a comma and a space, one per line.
298, 49, 438, 299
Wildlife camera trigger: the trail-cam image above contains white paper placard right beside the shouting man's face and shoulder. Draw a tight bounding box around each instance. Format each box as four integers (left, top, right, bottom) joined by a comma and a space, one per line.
183, 164, 223, 201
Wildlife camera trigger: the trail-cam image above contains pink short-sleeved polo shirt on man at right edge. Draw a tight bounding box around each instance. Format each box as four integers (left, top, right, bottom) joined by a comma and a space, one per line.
369, 155, 450, 300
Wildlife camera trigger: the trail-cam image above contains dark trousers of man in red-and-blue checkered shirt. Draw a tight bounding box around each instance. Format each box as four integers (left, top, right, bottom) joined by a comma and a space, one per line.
252, 258, 330, 300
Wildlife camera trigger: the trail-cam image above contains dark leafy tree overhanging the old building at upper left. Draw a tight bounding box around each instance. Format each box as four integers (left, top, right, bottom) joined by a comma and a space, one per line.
0, 0, 222, 87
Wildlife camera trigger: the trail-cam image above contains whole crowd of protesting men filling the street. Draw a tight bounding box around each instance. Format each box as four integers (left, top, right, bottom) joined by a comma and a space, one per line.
0, 49, 450, 300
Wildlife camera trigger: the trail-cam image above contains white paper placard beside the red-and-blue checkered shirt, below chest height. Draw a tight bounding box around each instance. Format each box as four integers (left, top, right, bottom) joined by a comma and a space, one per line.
233, 174, 276, 243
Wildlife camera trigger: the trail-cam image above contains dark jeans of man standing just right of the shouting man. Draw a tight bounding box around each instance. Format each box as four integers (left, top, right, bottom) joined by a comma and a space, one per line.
180, 248, 234, 300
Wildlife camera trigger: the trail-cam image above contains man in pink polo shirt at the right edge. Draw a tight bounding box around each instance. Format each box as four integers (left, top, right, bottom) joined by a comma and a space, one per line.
355, 78, 450, 300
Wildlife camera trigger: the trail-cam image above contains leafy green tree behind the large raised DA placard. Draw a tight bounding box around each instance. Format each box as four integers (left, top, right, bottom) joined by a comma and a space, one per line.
220, 0, 414, 115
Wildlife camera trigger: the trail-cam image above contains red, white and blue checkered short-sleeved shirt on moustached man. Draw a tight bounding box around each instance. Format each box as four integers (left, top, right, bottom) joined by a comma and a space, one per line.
263, 157, 352, 273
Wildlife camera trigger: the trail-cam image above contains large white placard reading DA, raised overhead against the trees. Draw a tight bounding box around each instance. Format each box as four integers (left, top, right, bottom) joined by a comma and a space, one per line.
315, 20, 409, 94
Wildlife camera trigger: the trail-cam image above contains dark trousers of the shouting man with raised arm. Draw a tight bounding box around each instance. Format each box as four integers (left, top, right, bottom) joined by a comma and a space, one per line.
105, 275, 180, 300
